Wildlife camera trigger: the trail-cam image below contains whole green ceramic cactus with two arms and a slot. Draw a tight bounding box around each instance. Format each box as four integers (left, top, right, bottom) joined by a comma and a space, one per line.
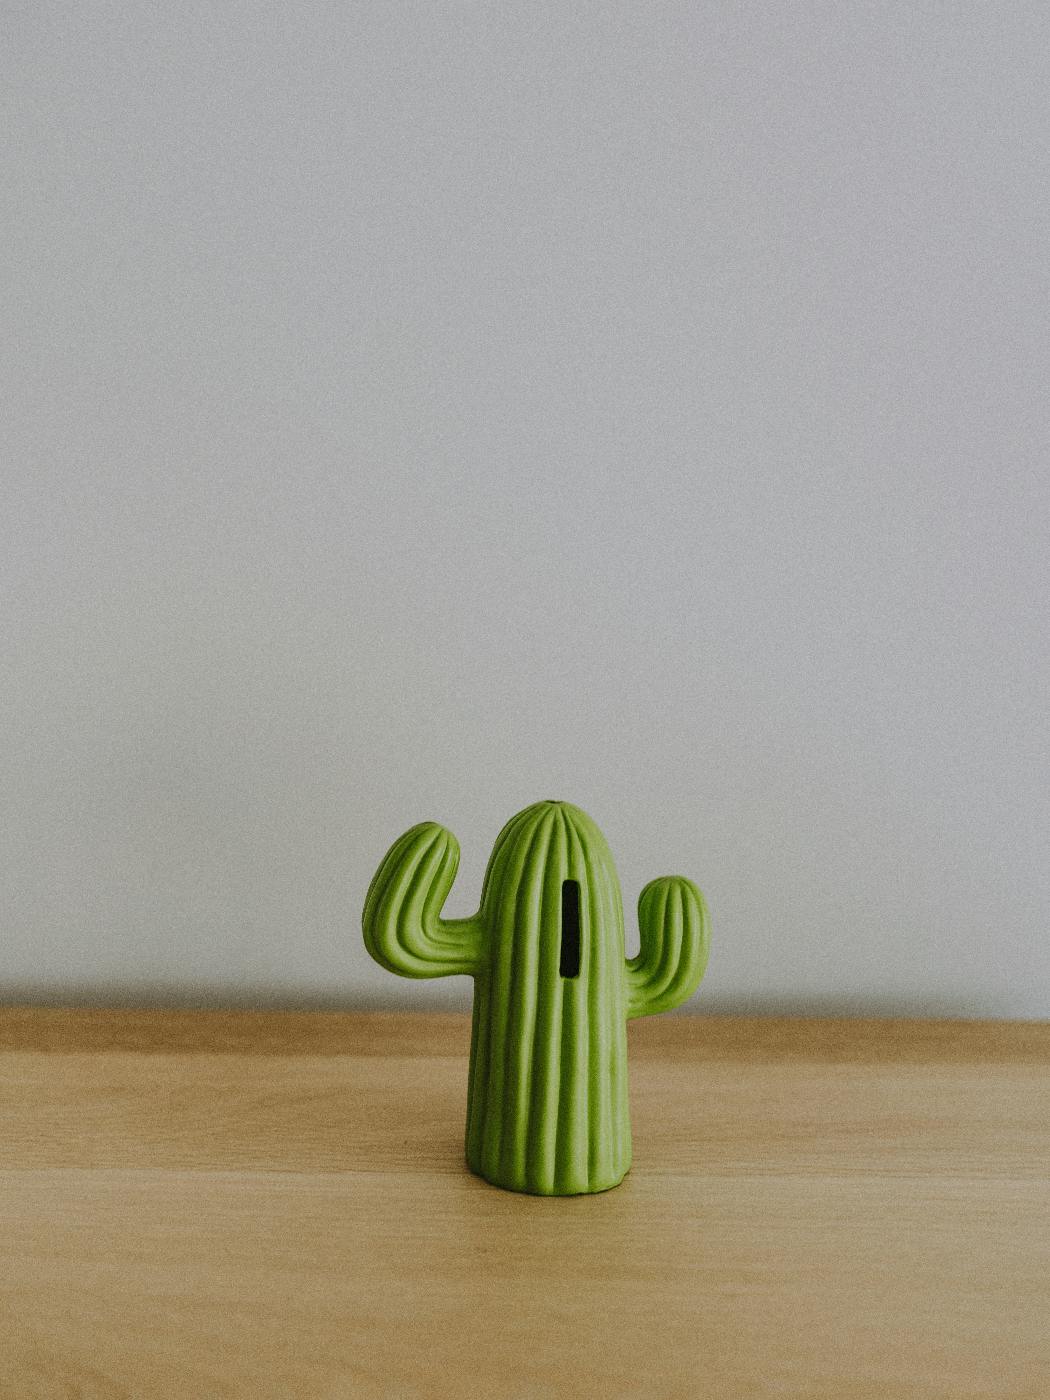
363, 802, 707, 1196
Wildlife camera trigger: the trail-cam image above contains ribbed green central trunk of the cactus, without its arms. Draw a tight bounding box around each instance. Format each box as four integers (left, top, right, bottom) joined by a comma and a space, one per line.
466, 804, 631, 1196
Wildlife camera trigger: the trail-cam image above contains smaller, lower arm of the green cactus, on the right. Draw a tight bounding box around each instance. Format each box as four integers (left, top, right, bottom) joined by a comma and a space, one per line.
626, 875, 708, 1016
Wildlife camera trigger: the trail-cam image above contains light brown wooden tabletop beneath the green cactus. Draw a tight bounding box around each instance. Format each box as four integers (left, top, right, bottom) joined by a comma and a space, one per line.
0, 1008, 1050, 1400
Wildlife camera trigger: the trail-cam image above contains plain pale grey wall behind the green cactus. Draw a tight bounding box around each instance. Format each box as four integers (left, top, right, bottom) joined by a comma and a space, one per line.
0, 8, 1050, 1018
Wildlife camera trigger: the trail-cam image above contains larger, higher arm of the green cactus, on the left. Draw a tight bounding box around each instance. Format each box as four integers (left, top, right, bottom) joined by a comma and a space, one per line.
363, 822, 482, 977
